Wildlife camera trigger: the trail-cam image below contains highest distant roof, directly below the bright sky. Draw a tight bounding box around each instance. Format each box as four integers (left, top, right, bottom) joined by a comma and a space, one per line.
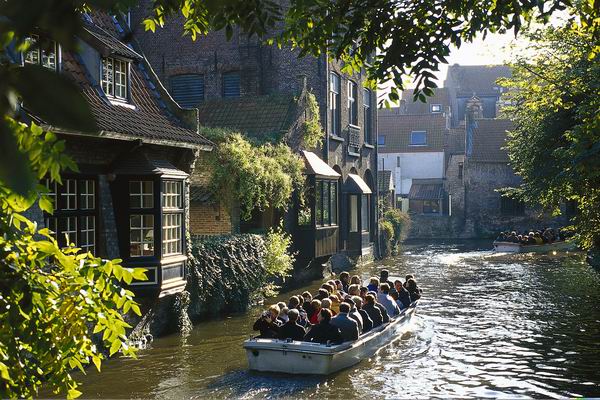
444, 64, 511, 96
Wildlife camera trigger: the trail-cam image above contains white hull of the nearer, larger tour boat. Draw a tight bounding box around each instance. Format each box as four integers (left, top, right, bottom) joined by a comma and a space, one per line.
244, 300, 419, 375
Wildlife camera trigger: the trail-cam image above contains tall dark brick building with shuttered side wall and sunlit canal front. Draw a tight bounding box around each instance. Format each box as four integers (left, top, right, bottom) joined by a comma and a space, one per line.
132, 6, 377, 259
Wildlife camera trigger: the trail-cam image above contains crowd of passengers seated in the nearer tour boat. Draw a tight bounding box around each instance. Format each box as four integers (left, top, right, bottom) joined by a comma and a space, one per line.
253, 270, 422, 344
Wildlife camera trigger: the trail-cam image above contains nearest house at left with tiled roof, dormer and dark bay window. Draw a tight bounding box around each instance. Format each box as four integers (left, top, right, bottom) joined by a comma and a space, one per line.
10, 13, 212, 297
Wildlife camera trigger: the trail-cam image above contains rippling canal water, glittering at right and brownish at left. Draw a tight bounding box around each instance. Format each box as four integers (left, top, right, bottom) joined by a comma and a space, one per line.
77, 243, 600, 399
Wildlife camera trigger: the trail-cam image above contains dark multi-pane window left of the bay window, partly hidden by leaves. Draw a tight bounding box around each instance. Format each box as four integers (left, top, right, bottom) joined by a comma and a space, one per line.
44, 177, 97, 254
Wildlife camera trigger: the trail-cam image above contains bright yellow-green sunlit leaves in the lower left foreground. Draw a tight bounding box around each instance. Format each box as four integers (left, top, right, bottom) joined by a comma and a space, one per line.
0, 118, 146, 398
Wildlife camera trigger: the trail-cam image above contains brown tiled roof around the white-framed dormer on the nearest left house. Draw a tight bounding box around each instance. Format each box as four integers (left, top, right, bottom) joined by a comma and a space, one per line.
50, 13, 212, 147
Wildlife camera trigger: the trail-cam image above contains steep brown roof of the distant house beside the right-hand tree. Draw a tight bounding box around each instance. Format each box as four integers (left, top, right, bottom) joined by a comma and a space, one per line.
469, 119, 513, 163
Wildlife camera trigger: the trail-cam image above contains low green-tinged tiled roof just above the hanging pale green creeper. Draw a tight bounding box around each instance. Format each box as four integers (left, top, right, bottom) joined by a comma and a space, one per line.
197, 94, 298, 137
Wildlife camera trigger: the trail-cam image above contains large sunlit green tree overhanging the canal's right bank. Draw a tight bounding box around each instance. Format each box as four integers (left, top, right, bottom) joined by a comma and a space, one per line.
502, 25, 600, 248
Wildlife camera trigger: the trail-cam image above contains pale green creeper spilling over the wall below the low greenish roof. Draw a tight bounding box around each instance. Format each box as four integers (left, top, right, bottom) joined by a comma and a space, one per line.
204, 130, 304, 219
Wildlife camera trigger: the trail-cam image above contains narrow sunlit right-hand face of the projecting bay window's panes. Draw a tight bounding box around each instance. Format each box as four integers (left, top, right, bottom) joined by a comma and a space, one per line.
162, 180, 183, 256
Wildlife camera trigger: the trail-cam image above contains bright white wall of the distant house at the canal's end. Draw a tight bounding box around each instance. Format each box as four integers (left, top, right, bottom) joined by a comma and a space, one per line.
378, 151, 444, 194
